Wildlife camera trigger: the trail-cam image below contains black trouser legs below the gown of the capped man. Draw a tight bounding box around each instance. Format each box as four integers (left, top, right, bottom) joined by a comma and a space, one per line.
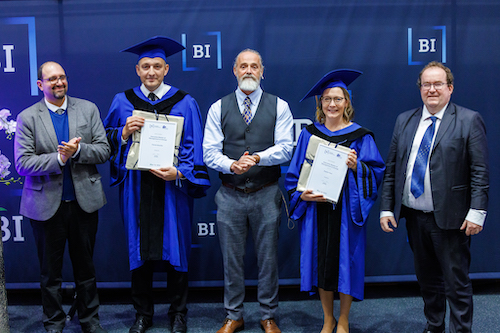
132, 260, 188, 319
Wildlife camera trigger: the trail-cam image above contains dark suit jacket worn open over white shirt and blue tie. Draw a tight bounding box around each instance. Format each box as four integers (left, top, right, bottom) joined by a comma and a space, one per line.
380, 102, 489, 229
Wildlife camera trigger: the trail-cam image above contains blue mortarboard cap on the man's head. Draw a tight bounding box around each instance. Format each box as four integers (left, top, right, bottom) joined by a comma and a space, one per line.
120, 36, 184, 61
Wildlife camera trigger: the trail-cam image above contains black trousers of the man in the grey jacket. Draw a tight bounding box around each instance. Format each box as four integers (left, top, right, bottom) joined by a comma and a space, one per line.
31, 201, 99, 330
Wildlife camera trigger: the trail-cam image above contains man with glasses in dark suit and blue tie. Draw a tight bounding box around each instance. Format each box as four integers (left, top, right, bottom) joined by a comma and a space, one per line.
380, 62, 489, 333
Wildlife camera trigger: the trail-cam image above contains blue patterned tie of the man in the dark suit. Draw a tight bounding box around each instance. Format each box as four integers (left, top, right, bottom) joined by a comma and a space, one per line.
411, 116, 437, 198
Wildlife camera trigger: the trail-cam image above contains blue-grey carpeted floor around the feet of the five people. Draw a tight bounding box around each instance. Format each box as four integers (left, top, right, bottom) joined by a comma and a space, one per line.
8, 281, 500, 333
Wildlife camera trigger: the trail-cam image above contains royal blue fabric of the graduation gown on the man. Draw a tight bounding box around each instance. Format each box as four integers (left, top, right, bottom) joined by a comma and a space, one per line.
104, 87, 210, 272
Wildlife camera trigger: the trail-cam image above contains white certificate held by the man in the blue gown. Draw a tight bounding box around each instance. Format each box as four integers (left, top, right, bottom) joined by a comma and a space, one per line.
137, 119, 177, 169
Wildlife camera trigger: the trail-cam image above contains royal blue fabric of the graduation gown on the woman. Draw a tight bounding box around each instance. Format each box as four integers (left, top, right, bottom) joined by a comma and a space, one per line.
285, 123, 385, 300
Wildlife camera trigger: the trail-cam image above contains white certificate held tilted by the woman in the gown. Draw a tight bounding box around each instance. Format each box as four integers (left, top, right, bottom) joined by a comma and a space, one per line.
306, 143, 350, 203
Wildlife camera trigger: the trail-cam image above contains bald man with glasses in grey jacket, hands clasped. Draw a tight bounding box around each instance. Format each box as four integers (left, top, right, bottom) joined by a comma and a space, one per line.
14, 61, 110, 333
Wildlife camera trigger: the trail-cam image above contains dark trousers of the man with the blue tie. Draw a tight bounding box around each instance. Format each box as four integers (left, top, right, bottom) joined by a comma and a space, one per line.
402, 207, 473, 333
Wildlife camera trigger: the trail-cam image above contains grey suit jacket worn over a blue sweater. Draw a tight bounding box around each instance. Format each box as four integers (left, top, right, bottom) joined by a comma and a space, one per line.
14, 96, 110, 221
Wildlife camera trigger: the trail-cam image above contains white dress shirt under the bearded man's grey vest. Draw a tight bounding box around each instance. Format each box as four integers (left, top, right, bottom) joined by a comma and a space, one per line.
203, 87, 293, 174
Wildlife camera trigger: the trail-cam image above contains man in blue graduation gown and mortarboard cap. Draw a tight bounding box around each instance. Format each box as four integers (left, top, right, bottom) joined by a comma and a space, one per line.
104, 36, 210, 333
